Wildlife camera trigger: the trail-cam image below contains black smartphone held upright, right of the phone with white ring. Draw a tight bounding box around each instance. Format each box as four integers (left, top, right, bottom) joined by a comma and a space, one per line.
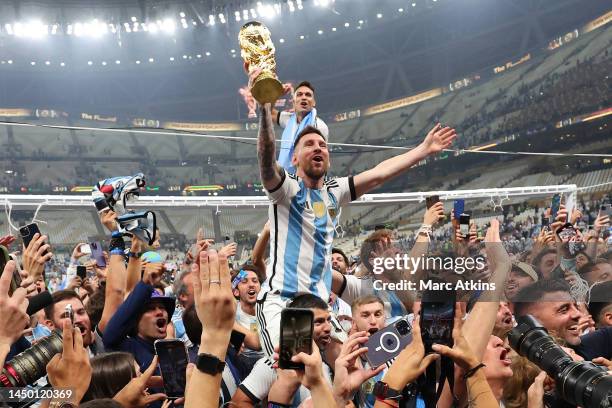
420, 291, 456, 353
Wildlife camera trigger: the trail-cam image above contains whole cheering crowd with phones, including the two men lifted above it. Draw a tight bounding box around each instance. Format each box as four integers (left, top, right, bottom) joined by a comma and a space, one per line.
0, 67, 612, 408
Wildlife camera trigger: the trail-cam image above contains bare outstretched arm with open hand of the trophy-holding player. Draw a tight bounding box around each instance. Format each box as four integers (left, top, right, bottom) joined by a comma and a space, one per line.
352, 124, 457, 196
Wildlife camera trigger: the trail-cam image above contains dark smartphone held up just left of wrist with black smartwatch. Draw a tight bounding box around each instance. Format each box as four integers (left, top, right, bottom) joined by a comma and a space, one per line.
153, 339, 188, 400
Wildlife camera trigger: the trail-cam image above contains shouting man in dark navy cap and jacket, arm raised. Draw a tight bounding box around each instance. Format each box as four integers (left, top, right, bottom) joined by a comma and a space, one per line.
103, 281, 174, 367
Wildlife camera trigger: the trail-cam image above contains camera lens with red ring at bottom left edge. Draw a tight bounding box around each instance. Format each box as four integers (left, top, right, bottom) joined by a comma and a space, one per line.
0, 331, 64, 387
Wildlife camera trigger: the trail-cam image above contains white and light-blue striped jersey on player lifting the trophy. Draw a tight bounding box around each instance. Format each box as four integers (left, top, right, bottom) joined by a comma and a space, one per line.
259, 171, 356, 299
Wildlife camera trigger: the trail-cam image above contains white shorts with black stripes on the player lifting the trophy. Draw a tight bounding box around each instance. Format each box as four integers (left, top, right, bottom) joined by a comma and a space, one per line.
255, 293, 289, 357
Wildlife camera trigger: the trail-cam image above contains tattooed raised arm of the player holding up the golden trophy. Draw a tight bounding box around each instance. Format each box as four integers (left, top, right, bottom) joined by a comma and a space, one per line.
257, 103, 282, 191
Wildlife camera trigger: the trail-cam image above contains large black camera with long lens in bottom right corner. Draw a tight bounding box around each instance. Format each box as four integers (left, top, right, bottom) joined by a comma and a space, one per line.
508, 315, 612, 408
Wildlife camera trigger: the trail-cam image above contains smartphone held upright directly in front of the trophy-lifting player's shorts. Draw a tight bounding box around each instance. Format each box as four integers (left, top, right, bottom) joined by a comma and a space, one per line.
278, 307, 314, 370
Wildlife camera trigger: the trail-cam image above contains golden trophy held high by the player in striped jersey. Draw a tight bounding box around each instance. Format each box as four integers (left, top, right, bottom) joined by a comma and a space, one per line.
238, 21, 283, 105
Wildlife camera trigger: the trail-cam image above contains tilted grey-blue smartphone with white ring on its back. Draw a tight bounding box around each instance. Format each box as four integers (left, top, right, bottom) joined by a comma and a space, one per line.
365, 318, 412, 368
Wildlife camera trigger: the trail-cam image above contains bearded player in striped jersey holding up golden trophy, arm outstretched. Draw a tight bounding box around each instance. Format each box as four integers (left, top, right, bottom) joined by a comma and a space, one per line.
240, 23, 456, 356
